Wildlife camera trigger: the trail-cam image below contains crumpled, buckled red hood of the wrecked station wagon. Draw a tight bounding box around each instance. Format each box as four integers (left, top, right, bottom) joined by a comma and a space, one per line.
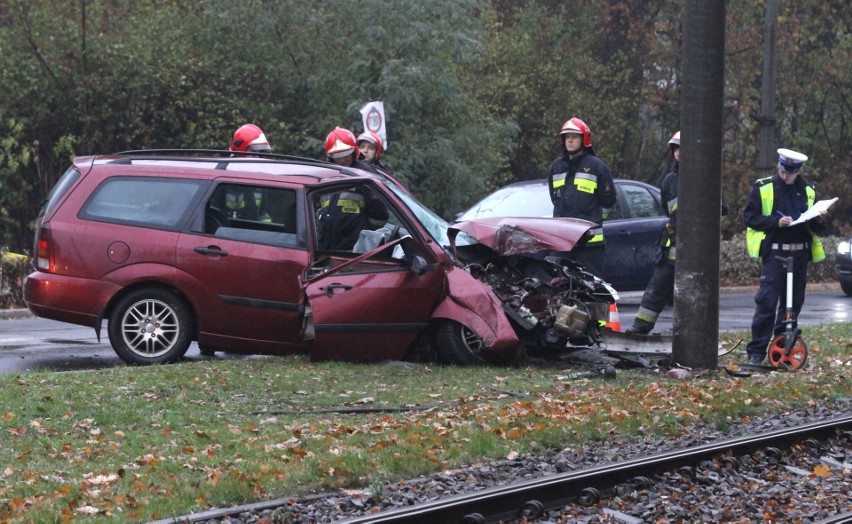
448, 217, 595, 256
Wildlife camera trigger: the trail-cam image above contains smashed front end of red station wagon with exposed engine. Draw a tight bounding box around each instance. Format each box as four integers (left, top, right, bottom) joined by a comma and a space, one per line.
439, 218, 618, 364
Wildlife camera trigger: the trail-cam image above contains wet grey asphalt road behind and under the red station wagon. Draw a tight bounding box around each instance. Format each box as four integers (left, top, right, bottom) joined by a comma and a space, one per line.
0, 289, 852, 373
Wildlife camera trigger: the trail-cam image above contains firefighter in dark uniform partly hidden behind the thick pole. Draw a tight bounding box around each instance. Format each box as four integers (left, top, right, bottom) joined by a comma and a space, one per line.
630, 131, 680, 335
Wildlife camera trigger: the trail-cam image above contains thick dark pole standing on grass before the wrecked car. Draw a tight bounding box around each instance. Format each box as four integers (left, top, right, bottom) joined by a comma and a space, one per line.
672, 0, 726, 369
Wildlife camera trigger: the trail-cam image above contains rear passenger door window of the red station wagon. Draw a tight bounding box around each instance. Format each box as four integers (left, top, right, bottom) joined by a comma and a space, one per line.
204, 184, 300, 247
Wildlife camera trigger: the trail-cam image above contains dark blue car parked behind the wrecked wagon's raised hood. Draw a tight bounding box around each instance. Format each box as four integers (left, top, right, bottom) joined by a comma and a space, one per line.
456, 179, 668, 291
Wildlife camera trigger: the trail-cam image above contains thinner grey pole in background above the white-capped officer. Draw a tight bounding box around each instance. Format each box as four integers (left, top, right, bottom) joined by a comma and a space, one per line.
757, 0, 778, 171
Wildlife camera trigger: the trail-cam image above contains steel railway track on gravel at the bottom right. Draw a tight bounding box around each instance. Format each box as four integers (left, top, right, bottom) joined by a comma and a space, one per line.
157, 415, 852, 524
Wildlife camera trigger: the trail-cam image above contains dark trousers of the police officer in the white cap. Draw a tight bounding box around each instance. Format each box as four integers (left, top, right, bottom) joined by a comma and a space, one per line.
746, 250, 810, 358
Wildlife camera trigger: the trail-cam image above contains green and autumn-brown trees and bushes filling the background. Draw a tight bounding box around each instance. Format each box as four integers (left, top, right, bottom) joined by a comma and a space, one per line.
0, 0, 852, 252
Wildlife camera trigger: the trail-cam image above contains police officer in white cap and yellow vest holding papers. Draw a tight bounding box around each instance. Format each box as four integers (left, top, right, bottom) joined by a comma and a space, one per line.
743, 148, 828, 364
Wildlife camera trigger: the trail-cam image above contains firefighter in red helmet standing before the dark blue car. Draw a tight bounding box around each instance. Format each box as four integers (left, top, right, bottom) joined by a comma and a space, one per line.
547, 117, 616, 276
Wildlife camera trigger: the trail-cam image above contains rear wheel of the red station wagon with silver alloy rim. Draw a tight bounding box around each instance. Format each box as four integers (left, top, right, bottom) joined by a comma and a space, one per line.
109, 288, 194, 365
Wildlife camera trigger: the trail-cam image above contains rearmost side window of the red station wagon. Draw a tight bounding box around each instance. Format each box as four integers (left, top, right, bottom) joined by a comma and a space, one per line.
80, 177, 202, 229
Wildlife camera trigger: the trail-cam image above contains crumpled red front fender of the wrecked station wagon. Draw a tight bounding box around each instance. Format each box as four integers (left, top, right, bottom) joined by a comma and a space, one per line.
432, 267, 519, 352
